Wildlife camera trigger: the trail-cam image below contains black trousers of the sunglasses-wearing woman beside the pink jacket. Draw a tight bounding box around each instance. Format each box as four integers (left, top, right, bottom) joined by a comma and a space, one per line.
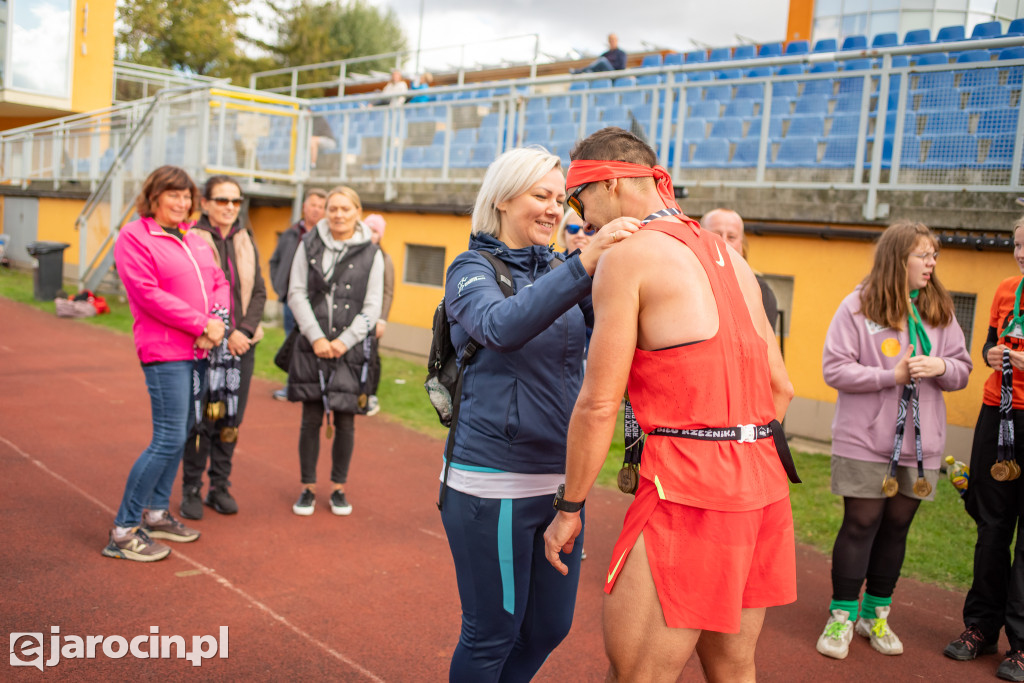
181, 346, 256, 487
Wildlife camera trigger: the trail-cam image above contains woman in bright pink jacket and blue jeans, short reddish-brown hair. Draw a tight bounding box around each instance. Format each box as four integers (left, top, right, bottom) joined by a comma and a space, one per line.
103, 166, 228, 562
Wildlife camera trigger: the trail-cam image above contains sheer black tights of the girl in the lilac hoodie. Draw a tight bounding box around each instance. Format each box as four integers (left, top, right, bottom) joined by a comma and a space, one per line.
833, 494, 921, 601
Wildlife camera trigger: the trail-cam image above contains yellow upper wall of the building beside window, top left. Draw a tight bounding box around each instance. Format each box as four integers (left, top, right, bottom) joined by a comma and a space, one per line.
71, 0, 115, 112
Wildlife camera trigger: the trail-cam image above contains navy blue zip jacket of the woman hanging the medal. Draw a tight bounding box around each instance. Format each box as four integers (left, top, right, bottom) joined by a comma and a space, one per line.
444, 234, 593, 474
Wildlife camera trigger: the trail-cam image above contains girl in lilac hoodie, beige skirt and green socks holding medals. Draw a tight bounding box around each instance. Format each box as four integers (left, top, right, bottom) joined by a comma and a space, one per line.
817, 221, 971, 659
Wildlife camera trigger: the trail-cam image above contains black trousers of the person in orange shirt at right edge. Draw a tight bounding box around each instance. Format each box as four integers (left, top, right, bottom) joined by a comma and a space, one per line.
964, 405, 1024, 650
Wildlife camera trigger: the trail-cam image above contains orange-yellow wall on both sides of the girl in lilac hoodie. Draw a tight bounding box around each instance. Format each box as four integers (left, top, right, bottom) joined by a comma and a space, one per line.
749, 236, 1019, 427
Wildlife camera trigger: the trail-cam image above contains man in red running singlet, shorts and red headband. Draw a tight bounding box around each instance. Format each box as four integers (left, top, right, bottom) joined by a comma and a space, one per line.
544, 128, 796, 682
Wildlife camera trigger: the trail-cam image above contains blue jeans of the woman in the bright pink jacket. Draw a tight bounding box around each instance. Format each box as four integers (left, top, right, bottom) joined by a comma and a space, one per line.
114, 360, 206, 526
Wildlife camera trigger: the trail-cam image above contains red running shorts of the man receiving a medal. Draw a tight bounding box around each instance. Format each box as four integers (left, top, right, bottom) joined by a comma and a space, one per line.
604, 477, 797, 633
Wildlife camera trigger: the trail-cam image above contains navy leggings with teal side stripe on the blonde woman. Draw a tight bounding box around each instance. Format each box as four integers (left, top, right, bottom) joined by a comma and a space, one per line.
441, 488, 583, 683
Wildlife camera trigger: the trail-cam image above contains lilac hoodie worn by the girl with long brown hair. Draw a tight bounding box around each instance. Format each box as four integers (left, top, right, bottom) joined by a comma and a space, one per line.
821, 286, 972, 470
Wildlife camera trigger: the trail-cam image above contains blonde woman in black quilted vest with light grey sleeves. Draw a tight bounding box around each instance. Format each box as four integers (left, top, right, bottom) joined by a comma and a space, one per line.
288, 186, 384, 516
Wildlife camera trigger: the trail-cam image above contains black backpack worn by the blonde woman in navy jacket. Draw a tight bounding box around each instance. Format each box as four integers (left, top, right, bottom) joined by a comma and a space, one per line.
423, 250, 515, 510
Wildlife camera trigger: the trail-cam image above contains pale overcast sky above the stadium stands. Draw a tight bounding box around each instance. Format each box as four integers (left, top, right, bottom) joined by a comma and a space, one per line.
247, 0, 788, 75
